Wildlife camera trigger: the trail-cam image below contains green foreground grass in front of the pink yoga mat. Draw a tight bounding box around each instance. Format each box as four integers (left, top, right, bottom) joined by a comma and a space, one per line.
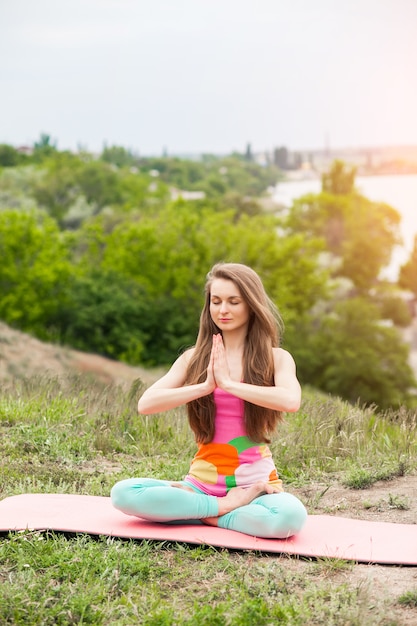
0, 532, 394, 626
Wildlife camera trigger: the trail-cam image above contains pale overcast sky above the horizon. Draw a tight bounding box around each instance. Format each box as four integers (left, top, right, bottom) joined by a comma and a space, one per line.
0, 0, 417, 155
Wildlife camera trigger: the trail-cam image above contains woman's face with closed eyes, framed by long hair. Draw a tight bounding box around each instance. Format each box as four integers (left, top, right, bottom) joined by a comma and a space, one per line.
210, 278, 250, 332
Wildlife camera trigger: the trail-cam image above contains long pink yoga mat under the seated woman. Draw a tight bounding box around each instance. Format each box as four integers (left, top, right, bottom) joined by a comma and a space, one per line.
0, 494, 417, 565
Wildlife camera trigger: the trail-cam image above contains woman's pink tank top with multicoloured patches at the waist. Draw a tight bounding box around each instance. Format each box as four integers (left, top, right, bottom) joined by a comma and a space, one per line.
185, 388, 282, 497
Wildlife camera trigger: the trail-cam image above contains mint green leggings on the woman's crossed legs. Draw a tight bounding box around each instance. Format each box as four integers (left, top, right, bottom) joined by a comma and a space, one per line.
111, 478, 307, 539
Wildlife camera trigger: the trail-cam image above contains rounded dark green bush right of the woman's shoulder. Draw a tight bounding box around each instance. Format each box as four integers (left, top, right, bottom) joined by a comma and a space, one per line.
292, 298, 416, 409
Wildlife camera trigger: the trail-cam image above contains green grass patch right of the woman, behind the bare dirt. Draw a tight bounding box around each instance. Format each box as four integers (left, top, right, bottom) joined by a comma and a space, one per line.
272, 392, 417, 482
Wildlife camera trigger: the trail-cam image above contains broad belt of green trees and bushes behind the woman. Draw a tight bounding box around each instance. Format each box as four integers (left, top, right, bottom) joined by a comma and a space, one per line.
0, 136, 415, 409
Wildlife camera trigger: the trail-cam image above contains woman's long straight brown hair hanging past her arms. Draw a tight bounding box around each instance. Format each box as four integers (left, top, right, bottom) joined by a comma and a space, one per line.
186, 263, 282, 443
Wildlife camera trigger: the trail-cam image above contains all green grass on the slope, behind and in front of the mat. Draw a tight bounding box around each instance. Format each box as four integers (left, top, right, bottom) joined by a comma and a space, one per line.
0, 377, 417, 626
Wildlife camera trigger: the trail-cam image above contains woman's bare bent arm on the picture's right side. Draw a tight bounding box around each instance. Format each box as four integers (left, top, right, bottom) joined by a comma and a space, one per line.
214, 340, 301, 413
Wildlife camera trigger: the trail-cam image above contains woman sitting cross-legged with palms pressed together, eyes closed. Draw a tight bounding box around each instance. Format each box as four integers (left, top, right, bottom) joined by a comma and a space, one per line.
111, 263, 307, 538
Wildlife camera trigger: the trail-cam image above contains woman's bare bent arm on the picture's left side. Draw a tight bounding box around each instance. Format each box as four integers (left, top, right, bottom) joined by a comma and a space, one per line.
138, 350, 215, 415
